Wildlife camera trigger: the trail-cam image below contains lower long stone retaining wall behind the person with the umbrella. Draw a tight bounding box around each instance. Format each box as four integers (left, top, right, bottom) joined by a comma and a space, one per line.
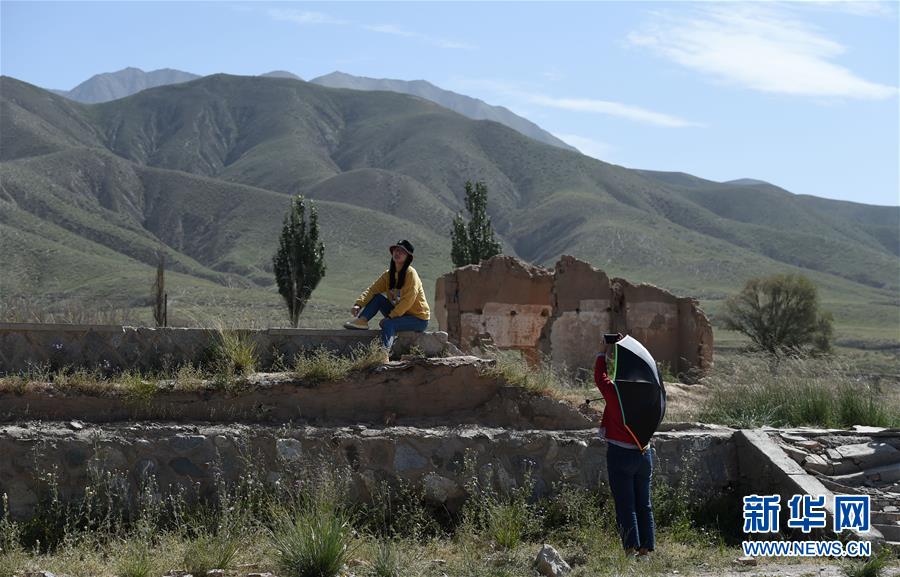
0, 422, 738, 518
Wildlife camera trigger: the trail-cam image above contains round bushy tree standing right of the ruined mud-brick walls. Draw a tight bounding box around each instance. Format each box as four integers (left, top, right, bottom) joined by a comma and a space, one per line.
724, 274, 833, 354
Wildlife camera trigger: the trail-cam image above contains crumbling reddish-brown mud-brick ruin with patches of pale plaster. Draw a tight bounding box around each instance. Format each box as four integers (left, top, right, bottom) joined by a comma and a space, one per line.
434, 256, 713, 378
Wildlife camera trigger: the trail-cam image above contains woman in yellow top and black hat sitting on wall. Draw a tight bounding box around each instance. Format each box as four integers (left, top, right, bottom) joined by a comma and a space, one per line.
344, 240, 431, 348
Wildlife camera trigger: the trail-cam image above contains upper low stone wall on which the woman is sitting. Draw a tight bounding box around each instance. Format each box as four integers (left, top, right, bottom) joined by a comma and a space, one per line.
0, 323, 458, 374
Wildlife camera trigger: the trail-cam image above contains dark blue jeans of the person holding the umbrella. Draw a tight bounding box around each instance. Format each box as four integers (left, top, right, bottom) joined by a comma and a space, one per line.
606, 443, 656, 551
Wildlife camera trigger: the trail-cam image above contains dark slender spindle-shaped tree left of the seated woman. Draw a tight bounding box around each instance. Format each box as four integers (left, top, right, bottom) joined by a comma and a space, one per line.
272, 196, 325, 327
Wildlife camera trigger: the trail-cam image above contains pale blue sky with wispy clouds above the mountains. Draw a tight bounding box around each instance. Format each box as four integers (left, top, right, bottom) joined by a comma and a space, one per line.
0, 1, 900, 205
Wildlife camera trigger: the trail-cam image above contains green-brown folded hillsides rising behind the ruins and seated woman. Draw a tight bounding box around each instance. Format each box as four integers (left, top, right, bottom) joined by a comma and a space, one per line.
0, 74, 900, 343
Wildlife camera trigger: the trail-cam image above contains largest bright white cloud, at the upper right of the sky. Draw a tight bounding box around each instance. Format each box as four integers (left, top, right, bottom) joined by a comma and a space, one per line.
628, 5, 897, 99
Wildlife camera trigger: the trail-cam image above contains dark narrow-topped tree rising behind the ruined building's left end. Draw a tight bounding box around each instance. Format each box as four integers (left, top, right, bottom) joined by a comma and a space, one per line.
450, 181, 500, 266
